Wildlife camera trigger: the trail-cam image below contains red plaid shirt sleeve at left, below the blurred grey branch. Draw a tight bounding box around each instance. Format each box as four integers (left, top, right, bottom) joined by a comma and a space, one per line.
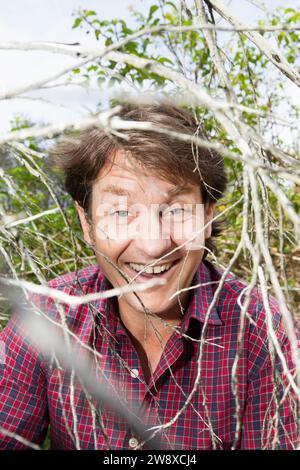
0, 315, 49, 450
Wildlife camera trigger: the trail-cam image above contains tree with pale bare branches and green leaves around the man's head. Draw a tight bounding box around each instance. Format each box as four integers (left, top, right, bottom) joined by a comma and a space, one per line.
0, 0, 300, 452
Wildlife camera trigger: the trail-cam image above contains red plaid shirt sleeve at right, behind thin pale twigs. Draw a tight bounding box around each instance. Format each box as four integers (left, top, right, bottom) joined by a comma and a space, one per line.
240, 324, 299, 450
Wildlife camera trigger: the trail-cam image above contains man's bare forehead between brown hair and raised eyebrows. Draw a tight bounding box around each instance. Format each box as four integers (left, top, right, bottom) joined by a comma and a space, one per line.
93, 152, 200, 197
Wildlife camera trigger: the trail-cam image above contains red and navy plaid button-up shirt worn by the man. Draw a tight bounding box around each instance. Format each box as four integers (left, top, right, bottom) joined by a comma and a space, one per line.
0, 260, 299, 450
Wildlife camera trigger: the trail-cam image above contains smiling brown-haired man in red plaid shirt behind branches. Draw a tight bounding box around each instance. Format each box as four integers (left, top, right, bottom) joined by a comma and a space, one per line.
0, 104, 299, 450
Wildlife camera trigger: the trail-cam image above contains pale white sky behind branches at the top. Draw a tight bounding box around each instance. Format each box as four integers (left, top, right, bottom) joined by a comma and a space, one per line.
0, 0, 300, 134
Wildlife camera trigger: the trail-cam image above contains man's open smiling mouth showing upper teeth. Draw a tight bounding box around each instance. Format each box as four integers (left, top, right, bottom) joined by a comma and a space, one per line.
125, 259, 179, 282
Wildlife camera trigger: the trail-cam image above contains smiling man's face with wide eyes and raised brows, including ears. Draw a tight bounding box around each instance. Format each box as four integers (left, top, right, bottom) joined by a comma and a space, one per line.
77, 152, 214, 318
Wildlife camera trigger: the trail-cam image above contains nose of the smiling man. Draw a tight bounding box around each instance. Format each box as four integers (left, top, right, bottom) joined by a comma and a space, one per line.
133, 209, 172, 260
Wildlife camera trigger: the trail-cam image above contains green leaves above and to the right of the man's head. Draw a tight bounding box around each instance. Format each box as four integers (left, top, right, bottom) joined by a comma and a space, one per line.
66, 0, 300, 304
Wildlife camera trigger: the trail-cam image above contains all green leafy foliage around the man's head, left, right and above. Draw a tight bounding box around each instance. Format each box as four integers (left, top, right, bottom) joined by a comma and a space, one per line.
0, 0, 300, 448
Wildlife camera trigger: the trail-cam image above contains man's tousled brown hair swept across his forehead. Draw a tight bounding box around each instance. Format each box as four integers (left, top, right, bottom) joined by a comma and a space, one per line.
53, 103, 227, 256
